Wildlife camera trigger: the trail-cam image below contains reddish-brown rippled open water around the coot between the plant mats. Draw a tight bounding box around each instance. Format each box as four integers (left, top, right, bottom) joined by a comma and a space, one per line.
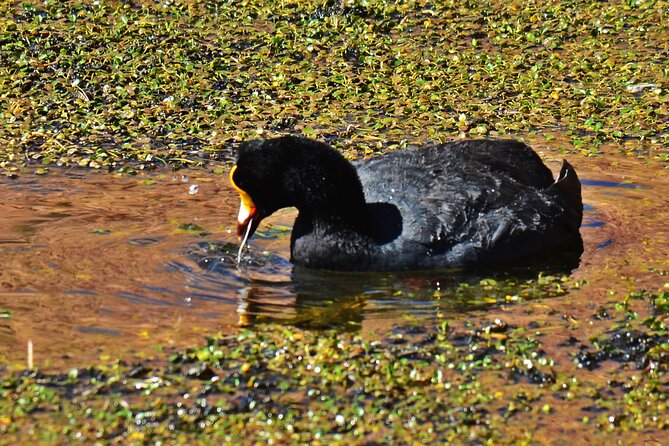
0, 145, 669, 366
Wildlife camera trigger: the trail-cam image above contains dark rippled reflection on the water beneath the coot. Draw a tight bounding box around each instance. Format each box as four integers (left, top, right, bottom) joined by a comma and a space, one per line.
188, 243, 583, 331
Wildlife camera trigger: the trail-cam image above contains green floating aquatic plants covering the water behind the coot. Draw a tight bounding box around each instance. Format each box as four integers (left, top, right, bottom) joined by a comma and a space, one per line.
0, 0, 669, 173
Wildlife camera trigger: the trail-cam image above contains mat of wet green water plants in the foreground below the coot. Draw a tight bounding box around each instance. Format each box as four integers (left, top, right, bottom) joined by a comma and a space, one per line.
0, 293, 669, 444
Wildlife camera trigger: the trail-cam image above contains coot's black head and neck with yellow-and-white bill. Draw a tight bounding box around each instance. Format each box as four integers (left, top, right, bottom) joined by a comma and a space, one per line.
230, 136, 365, 242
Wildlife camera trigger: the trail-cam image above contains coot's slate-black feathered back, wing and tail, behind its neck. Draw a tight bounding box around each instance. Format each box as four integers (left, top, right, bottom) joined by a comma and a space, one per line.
356, 140, 582, 269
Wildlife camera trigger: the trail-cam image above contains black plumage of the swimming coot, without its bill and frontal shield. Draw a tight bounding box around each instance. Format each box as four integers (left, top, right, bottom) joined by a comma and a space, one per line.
233, 136, 583, 271
